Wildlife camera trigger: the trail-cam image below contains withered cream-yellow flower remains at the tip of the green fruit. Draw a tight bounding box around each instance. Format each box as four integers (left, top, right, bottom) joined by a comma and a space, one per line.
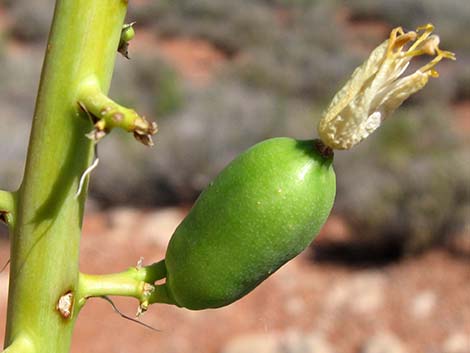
318, 24, 455, 150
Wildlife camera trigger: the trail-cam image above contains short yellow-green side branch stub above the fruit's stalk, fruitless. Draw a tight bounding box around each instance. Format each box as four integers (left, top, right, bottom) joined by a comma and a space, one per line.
78, 80, 157, 146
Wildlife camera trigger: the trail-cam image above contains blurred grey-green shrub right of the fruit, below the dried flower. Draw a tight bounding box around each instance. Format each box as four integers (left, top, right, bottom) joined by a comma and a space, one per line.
336, 107, 470, 253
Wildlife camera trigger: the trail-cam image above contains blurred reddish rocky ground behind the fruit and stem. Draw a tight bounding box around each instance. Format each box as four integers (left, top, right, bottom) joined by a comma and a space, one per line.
0, 208, 470, 353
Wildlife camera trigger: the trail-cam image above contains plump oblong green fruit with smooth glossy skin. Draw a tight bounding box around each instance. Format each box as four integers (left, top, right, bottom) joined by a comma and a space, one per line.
164, 138, 336, 310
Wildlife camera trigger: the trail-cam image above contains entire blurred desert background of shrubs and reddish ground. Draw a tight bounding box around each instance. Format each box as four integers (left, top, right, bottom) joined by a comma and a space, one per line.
0, 0, 470, 353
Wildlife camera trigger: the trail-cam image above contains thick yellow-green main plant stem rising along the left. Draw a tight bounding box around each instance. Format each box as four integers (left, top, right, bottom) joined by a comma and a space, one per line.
5, 0, 127, 353
